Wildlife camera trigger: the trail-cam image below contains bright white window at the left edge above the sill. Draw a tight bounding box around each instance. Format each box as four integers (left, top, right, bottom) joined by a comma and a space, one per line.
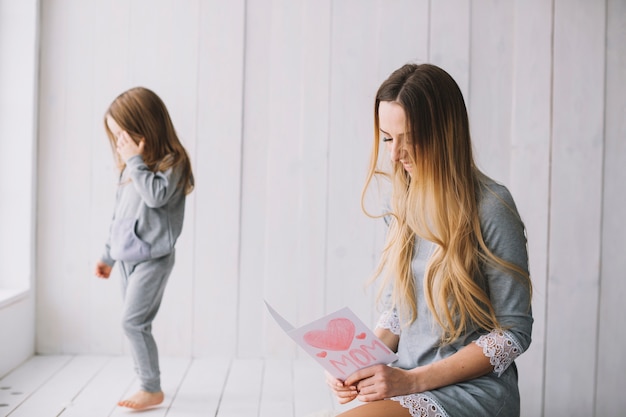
0, 0, 38, 307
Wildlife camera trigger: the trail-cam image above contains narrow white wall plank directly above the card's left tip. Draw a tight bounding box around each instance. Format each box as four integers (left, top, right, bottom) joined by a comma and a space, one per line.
237, 0, 271, 357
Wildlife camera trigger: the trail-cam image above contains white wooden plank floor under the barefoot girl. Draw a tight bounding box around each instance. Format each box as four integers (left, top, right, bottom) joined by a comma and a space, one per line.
0, 356, 357, 417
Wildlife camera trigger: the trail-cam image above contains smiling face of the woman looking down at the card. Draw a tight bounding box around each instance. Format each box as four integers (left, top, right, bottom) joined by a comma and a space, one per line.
378, 101, 413, 175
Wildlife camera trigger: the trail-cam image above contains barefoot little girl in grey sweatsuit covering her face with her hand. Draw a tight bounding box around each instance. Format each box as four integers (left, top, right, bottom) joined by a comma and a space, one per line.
95, 87, 194, 410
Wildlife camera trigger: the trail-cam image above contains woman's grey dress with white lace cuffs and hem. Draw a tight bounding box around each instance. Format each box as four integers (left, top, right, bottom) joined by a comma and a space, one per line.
377, 179, 533, 417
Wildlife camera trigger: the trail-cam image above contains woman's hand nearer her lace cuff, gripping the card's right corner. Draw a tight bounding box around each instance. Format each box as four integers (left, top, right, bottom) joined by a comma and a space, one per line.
344, 365, 419, 402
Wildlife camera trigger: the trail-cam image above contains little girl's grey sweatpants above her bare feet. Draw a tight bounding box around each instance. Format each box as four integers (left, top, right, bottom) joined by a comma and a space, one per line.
120, 252, 175, 392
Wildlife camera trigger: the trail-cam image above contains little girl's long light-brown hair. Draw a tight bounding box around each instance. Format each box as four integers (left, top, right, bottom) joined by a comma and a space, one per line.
104, 87, 194, 194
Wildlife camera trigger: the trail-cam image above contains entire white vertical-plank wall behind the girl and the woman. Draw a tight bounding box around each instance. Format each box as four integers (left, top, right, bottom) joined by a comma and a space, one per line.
30, 0, 626, 417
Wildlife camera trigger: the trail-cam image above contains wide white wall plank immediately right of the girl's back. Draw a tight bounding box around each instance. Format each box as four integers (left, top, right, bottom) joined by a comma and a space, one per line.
191, 1, 245, 356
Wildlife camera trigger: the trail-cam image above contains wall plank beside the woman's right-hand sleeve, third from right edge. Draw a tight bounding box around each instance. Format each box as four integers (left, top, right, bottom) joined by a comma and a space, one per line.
510, 1, 552, 417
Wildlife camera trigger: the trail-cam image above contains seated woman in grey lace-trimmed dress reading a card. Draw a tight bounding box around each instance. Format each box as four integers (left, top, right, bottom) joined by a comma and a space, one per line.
327, 64, 533, 417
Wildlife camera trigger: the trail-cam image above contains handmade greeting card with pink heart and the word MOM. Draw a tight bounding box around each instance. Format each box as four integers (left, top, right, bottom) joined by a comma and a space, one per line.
265, 302, 398, 380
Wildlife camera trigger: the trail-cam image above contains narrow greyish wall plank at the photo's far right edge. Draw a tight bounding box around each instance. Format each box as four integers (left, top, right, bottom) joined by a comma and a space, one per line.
595, 0, 626, 417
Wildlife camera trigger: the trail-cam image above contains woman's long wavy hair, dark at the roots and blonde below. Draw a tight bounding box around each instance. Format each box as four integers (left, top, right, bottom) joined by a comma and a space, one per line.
361, 64, 531, 343
